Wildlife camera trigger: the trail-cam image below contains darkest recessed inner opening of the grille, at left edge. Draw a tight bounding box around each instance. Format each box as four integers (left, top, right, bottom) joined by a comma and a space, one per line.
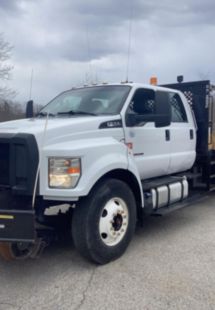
0, 143, 10, 186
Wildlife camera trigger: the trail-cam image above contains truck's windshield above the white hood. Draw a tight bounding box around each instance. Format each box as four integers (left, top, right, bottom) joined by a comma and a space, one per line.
39, 85, 131, 116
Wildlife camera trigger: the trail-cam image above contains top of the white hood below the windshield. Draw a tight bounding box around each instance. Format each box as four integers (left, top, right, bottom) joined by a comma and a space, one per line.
0, 115, 122, 145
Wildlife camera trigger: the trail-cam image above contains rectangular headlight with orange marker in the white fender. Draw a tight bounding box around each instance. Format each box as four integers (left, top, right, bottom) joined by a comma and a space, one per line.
49, 157, 81, 189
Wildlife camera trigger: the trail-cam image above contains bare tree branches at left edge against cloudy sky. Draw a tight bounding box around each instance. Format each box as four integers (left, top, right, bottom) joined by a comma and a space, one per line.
0, 33, 15, 99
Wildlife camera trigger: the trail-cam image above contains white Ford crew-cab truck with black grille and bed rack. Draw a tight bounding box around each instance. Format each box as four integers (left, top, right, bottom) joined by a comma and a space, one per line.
0, 81, 215, 264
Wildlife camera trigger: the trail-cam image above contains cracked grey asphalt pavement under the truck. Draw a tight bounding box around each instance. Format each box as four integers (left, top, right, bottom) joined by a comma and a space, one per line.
0, 194, 215, 310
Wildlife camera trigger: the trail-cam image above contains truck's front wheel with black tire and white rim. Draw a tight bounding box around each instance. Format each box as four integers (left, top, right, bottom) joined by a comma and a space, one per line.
72, 179, 136, 264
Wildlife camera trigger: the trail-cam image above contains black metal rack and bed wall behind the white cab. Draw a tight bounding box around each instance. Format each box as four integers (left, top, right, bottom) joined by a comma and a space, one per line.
161, 80, 215, 190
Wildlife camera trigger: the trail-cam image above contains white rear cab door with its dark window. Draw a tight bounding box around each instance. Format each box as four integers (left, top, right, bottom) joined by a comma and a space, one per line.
169, 92, 196, 173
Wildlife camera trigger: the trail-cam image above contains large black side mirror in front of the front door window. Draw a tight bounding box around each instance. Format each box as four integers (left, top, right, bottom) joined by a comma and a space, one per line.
155, 91, 171, 128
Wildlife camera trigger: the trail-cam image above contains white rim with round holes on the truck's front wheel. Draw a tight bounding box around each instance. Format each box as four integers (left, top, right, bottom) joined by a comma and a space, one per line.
99, 198, 129, 246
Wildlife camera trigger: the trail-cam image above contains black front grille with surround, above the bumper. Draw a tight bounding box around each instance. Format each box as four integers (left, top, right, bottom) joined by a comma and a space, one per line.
0, 132, 39, 195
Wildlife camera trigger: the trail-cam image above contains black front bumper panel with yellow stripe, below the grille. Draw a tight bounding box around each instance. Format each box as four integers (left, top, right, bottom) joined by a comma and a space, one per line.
0, 210, 36, 242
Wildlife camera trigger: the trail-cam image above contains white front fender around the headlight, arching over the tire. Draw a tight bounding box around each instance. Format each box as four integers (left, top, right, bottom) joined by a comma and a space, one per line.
40, 137, 132, 200
